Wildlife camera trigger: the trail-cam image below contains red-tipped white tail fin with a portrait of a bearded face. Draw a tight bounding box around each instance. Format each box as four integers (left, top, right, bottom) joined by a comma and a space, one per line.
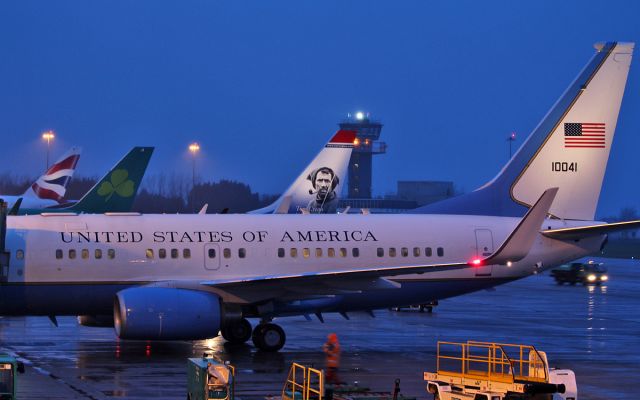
250, 129, 356, 214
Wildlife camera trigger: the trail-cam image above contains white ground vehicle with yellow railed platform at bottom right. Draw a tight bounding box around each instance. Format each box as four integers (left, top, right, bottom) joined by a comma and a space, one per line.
424, 341, 578, 400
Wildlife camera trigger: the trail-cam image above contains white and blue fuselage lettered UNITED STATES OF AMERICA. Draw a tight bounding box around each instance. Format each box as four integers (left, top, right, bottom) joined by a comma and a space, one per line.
0, 215, 604, 315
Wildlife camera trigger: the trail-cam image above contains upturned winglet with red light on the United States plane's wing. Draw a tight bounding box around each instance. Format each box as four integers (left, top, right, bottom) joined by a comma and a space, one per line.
478, 188, 558, 265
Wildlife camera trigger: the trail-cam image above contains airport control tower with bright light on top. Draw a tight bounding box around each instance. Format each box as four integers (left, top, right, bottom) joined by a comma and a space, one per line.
340, 111, 387, 199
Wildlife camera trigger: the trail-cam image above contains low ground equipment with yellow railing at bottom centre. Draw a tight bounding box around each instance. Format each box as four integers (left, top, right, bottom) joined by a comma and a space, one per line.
280, 363, 416, 400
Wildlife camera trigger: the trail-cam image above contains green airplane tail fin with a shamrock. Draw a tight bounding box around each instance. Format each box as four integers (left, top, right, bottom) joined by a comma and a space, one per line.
65, 147, 154, 214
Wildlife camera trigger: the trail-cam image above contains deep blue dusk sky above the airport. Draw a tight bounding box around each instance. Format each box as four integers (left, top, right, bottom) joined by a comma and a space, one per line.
0, 0, 640, 216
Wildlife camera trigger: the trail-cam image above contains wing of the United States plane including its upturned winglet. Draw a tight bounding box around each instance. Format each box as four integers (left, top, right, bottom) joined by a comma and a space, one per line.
179, 188, 558, 303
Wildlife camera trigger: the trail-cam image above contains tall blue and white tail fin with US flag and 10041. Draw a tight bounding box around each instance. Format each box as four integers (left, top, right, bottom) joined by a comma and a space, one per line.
414, 42, 634, 220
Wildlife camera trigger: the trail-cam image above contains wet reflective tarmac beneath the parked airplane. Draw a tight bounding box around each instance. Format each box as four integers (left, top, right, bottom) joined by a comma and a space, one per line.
0, 260, 640, 400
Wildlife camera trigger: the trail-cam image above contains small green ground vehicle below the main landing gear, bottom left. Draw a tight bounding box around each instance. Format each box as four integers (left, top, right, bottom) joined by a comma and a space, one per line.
187, 354, 235, 400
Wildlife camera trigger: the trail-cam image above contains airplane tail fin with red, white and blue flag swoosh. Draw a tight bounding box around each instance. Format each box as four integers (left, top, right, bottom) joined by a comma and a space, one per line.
22, 147, 81, 203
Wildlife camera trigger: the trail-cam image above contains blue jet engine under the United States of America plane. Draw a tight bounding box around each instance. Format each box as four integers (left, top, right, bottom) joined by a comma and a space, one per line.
113, 287, 222, 340
